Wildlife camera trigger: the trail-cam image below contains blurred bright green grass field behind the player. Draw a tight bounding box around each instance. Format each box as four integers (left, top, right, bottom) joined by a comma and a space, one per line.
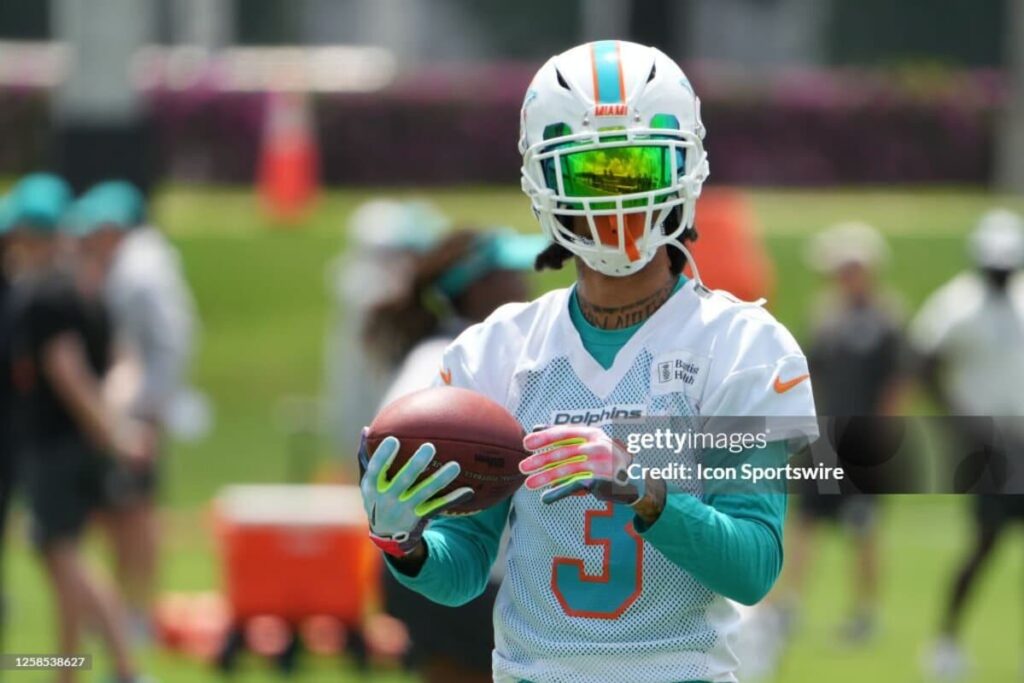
4, 187, 1024, 683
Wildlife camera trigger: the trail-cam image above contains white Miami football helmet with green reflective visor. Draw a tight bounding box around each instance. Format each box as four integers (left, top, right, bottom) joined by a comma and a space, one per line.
519, 40, 709, 276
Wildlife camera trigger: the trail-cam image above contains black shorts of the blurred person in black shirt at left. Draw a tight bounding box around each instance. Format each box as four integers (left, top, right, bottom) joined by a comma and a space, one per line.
19, 438, 111, 548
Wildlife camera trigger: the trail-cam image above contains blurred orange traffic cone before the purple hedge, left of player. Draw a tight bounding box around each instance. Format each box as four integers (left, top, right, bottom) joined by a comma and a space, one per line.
258, 92, 319, 223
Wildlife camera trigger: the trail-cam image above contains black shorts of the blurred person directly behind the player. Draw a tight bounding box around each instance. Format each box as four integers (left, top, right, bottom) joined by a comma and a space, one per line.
383, 567, 498, 674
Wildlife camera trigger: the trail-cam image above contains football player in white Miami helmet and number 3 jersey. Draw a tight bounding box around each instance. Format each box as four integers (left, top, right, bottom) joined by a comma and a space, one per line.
360, 41, 816, 683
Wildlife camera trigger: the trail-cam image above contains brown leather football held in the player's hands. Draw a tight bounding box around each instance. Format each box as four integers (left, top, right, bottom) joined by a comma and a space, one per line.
367, 386, 526, 515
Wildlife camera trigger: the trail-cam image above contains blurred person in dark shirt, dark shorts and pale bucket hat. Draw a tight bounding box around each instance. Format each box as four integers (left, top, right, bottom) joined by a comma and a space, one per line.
776, 222, 907, 644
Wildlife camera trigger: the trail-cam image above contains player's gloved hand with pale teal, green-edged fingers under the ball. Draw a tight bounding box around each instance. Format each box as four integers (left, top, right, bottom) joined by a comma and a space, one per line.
359, 431, 473, 557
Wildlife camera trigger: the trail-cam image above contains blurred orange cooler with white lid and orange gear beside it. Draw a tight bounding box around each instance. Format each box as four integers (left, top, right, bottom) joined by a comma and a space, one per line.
167, 484, 380, 671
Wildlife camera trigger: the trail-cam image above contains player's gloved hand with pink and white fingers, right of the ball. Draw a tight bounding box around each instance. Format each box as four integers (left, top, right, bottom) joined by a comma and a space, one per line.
519, 426, 644, 505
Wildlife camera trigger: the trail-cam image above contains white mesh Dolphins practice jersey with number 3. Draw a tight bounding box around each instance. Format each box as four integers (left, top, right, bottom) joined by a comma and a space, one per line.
441, 281, 817, 683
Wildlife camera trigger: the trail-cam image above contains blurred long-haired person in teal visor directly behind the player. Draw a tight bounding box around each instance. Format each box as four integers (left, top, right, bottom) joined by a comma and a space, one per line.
362, 229, 547, 683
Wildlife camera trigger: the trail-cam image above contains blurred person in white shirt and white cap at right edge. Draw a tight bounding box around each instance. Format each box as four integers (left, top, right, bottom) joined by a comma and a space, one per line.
910, 209, 1024, 679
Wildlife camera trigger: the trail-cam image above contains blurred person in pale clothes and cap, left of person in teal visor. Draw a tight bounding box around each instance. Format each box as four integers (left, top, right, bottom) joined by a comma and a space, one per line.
324, 199, 451, 473
